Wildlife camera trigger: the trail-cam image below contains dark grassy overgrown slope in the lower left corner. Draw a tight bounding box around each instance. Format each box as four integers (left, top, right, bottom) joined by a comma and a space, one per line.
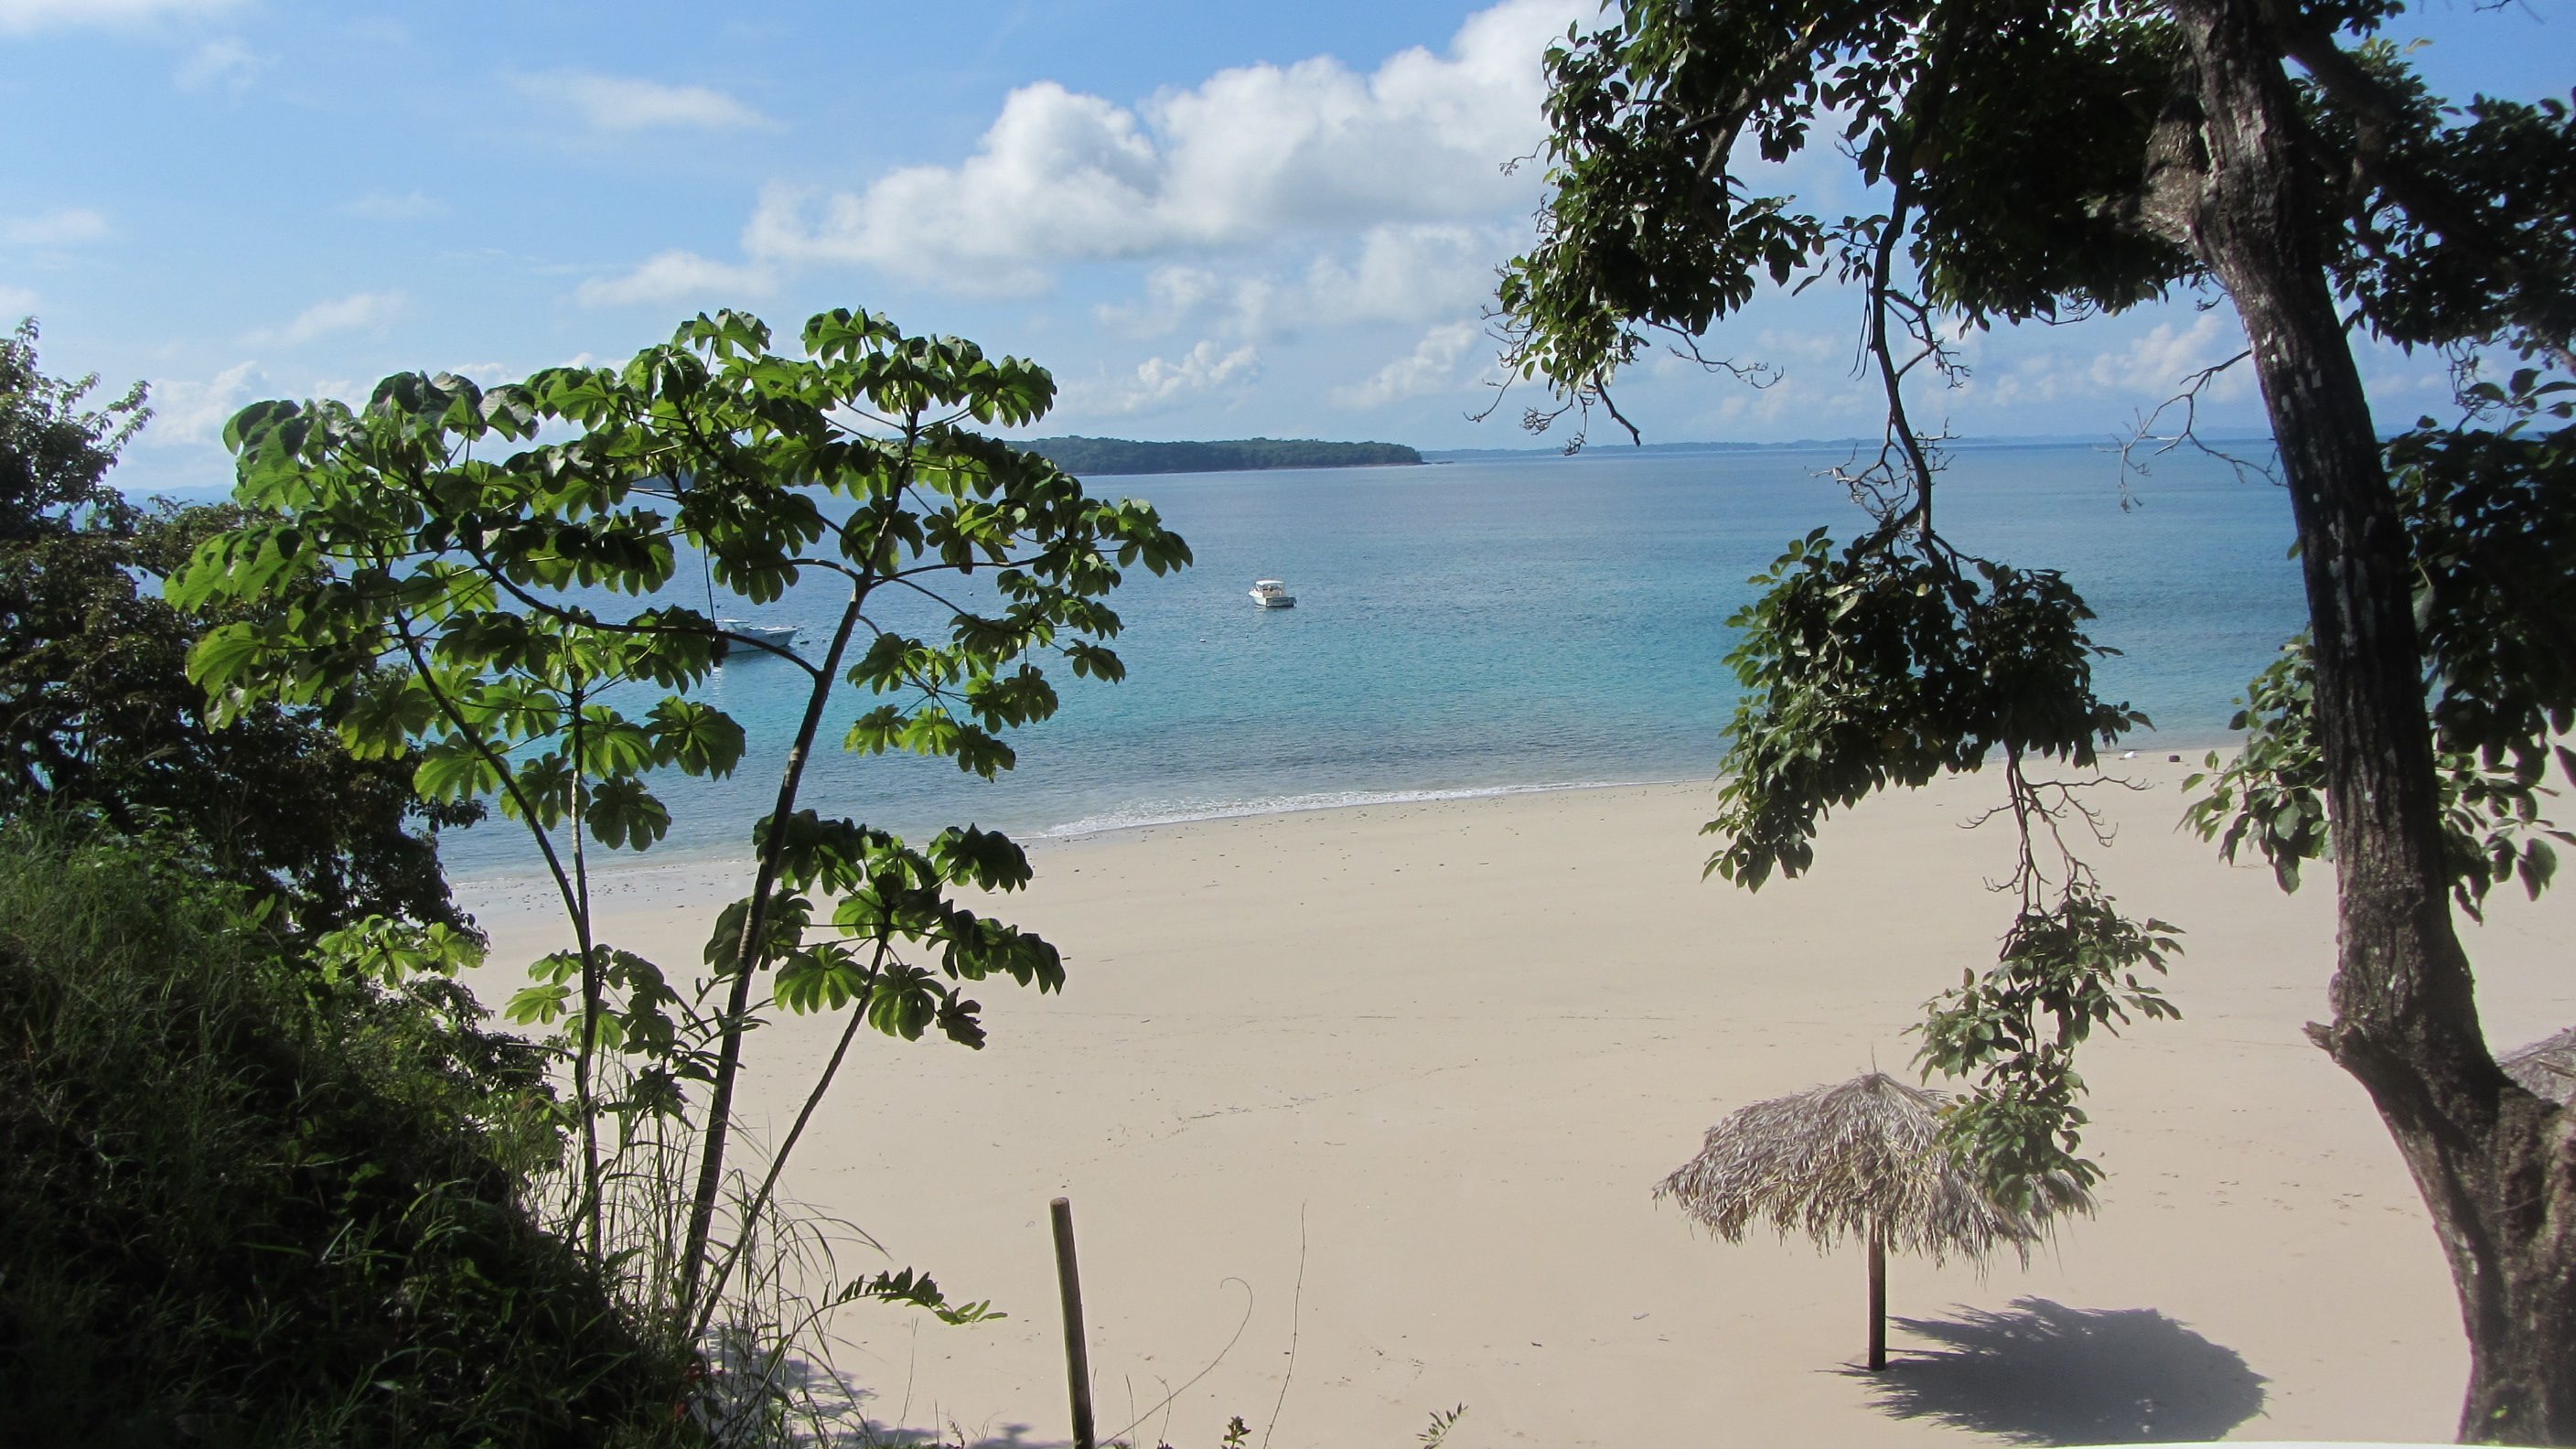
0, 817, 672, 1446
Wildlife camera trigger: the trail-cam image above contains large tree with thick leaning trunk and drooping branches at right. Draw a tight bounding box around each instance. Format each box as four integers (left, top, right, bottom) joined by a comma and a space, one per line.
1502, 0, 2576, 1444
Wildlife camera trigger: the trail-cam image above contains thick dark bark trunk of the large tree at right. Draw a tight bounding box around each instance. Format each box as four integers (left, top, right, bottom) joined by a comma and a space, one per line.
2174, 0, 2576, 1444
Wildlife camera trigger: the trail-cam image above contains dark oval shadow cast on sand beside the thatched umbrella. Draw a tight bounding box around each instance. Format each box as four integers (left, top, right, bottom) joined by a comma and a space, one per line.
1844, 1297, 2264, 1444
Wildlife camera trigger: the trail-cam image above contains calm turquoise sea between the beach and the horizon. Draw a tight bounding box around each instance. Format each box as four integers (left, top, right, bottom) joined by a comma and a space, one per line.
445, 446, 2301, 876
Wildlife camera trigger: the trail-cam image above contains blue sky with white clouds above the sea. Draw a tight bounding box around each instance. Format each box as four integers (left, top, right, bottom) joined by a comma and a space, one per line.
0, 0, 2576, 492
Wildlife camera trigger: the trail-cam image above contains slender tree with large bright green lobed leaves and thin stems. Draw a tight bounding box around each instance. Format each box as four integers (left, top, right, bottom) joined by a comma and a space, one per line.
175, 312, 1190, 1343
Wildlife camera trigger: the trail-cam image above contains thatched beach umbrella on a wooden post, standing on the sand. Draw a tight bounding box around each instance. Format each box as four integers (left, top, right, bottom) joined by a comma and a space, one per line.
1654, 1072, 2092, 1369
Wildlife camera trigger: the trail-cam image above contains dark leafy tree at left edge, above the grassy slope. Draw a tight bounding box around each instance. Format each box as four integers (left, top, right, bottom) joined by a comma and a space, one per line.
0, 322, 479, 933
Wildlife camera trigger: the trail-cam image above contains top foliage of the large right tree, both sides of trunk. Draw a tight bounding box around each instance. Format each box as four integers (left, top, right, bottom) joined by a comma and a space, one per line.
1499, 0, 2576, 417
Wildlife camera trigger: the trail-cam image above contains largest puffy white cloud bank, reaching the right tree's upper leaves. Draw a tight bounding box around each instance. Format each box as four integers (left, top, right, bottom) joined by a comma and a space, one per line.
745, 0, 1587, 289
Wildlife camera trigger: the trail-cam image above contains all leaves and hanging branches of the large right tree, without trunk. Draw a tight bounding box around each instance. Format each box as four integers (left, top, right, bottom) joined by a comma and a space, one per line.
1499, 0, 2576, 1194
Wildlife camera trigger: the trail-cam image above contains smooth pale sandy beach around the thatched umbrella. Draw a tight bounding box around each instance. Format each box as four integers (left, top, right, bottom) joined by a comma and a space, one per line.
467, 753, 2576, 1449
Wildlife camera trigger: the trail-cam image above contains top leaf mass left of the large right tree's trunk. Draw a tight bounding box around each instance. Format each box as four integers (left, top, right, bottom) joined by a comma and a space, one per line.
1499, 0, 2192, 423
